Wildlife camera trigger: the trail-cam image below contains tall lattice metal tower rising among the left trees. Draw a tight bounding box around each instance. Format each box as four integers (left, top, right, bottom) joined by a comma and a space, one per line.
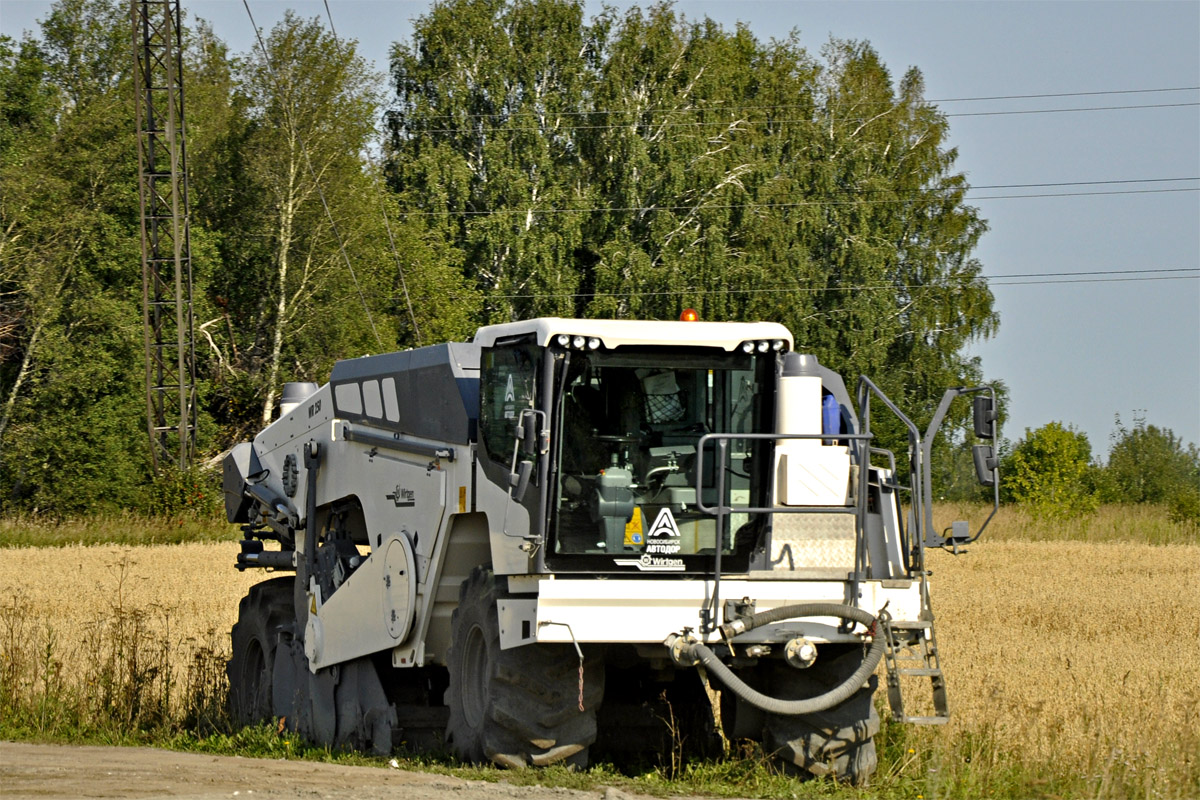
131, 0, 196, 471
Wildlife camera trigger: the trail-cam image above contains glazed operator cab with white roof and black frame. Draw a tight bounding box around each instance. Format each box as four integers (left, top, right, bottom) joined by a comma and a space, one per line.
476, 319, 791, 573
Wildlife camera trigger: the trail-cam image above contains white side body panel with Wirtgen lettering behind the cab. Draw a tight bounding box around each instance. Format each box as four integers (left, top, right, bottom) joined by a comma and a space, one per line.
254, 398, 477, 672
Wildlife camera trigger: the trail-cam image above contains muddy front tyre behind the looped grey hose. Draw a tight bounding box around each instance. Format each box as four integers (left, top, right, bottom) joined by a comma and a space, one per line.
763, 648, 880, 786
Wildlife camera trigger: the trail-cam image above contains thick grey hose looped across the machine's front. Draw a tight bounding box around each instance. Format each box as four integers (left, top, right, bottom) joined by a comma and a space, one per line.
677, 603, 887, 716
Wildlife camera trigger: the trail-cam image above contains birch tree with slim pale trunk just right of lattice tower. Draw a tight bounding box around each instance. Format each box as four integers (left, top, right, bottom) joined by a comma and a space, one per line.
197, 13, 396, 425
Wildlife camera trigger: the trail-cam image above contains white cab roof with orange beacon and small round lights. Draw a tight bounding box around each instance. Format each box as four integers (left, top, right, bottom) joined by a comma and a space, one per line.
474, 317, 792, 351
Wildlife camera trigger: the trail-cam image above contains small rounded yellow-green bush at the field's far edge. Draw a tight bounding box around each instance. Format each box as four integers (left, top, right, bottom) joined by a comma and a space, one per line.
1002, 422, 1099, 519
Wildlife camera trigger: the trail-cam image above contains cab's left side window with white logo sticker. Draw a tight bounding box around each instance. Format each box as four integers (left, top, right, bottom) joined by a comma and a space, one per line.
479, 347, 540, 463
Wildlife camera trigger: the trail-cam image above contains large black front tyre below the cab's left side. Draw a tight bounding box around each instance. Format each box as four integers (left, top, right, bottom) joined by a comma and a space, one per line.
446, 567, 604, 769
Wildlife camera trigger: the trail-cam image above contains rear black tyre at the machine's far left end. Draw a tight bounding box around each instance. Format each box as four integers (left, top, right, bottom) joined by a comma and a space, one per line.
226, 578, 295, 726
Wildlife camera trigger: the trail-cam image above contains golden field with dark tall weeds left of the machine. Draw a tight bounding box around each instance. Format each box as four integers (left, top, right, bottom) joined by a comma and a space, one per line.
0, 542, 264, 735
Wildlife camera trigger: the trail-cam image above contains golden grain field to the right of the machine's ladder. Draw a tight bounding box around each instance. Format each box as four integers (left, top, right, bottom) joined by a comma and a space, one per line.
929, 542, 1200, 796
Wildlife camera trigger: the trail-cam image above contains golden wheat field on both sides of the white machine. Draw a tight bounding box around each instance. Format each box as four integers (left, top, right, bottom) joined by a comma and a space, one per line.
0, 527, 1200, 798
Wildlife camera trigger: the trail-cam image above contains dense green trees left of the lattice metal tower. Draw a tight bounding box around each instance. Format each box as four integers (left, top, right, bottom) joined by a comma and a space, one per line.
0, 0, 153, 512
